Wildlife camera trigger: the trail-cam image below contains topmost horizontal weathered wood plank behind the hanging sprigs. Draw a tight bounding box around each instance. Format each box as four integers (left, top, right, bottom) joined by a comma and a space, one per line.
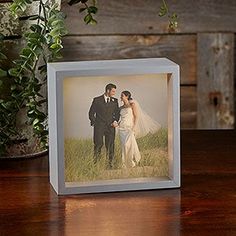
62, 0, 236, 35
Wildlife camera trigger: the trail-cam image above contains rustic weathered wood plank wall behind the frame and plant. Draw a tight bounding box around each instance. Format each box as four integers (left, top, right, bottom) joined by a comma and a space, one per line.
0, 0, 236, 129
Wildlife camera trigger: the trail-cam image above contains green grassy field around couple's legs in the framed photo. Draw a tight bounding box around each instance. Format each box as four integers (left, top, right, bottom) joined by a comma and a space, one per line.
65, 129, 168, 182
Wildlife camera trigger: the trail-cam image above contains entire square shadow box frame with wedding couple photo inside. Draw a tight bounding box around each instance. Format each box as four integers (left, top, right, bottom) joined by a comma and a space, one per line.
48, 58, 180, 195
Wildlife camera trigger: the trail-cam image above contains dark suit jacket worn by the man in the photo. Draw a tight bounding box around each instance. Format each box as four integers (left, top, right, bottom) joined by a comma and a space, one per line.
89, 95, 120, 125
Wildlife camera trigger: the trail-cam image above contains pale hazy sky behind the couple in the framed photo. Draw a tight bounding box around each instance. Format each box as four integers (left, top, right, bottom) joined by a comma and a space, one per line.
63, 74, 168, 138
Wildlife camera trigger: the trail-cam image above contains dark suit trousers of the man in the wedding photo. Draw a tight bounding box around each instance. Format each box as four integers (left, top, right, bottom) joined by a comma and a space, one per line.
93, 123, 115, 165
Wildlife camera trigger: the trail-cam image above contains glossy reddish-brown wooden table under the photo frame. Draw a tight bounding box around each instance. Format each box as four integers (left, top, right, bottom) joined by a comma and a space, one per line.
0, 131, 236, 236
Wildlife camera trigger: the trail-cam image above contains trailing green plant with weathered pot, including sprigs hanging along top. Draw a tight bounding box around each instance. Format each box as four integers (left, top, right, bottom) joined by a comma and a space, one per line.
0, 0, 177, 157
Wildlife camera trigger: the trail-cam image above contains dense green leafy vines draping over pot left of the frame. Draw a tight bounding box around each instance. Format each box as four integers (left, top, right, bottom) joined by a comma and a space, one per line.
0, 0, 67, 152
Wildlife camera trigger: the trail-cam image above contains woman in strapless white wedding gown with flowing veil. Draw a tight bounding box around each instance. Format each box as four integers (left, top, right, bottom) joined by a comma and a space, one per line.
117, 91, 161, 168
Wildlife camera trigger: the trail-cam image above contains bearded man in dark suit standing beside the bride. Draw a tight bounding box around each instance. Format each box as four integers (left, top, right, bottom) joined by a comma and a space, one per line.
89, 84, 120, 167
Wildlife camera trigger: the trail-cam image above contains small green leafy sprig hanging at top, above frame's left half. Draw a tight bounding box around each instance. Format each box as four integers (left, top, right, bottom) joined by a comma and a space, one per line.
68, 0, 98, 25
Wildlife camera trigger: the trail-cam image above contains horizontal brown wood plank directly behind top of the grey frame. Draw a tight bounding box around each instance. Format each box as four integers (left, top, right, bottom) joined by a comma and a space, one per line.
63, 35, 197, 85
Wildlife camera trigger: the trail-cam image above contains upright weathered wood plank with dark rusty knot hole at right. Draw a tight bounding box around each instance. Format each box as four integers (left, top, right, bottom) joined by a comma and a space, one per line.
197, 33, 234, 129
